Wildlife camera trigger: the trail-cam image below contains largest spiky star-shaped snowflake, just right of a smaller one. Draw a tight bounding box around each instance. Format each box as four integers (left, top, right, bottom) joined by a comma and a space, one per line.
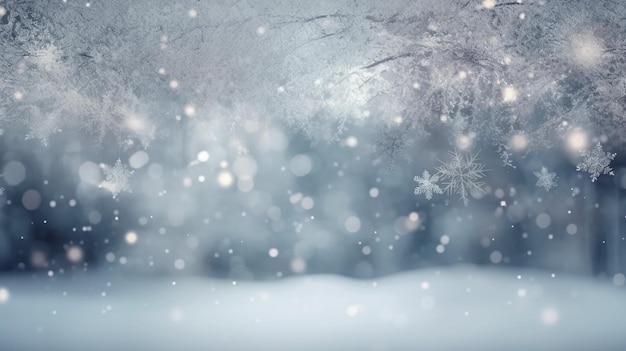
435, 150, 486, 206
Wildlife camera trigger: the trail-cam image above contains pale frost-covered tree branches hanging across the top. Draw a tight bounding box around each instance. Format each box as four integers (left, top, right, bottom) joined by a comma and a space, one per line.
0, 0, 626, 158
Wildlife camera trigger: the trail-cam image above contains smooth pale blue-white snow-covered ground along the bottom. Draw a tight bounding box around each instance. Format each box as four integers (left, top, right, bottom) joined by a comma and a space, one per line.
0, 266, 626, 351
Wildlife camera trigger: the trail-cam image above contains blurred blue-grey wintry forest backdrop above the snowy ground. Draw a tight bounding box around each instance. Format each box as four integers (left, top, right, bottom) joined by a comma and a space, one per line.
0, 0, 626, 285
